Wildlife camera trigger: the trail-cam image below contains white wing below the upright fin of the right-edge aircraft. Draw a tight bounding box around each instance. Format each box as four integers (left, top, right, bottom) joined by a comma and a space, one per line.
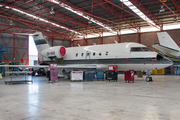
152, 44, 179, 53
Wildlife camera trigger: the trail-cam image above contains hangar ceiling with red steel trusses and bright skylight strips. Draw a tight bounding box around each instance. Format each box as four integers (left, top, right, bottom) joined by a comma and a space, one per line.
0, 0, 180, 40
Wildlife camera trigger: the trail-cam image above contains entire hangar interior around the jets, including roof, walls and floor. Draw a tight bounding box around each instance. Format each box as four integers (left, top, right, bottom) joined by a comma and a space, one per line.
0, 0, 180, 120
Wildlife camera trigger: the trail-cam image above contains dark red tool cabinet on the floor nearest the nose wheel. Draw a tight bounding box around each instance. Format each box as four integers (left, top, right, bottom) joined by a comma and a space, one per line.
124, 70, 134, 83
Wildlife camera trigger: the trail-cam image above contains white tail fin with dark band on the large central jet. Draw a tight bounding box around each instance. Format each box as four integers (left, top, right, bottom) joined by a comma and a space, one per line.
32, 32, 50, 61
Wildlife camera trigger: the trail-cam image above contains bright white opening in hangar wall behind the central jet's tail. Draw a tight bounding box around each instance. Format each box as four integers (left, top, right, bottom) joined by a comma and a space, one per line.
29, 35, 38, 65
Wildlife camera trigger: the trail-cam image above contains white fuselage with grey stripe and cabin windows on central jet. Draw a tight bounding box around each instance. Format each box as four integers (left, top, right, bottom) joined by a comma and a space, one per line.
41, 43, 172, 70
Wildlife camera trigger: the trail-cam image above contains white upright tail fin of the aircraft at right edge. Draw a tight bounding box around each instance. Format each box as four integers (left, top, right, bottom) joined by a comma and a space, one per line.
157, 32, 179, 50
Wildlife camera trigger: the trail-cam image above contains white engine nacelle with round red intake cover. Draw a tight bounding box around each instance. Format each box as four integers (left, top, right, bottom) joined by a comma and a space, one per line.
41, 46, 66, 58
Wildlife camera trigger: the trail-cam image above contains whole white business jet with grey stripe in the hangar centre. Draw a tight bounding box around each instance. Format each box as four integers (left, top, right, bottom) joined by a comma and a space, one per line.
0, 32, 173, 79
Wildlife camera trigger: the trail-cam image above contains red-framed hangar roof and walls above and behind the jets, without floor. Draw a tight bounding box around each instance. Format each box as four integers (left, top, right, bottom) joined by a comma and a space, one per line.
0, 0, 180, 72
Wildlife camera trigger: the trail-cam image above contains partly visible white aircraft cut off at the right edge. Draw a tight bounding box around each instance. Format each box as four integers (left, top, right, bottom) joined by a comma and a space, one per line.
152, 32, 180, 65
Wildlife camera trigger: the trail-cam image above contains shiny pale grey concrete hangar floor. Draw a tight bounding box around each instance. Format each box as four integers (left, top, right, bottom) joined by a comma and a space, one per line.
0, 75, 180, 120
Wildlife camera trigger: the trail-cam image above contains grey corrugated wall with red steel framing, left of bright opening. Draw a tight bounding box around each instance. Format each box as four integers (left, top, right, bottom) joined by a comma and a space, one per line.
0, 33, 29, 64
